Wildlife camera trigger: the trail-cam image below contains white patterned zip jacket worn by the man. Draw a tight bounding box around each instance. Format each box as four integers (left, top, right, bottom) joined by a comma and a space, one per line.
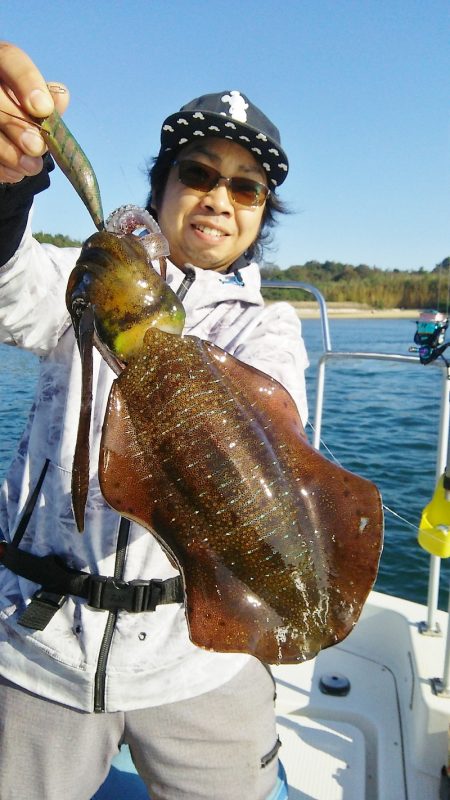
0, 212, 308, 711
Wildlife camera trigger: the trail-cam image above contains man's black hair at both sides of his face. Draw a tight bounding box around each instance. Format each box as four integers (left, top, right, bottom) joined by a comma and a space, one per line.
145, 145, 289, 261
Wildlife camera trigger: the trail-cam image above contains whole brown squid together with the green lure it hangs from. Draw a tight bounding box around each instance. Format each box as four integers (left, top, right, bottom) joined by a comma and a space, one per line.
23, 100, 383, 663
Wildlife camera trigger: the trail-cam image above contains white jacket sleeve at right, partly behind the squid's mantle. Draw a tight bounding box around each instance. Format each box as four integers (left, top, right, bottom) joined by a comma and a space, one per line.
233, 303, 309, 426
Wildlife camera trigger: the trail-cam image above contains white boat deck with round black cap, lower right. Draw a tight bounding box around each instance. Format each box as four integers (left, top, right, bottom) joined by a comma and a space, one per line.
274, 592, 450, 800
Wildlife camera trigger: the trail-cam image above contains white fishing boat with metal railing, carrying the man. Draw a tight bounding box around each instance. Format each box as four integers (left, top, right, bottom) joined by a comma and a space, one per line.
86, 281, 450, 800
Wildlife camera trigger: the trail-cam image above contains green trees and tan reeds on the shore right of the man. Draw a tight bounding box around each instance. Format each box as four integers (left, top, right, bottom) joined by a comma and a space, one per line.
261, 257, 450, 311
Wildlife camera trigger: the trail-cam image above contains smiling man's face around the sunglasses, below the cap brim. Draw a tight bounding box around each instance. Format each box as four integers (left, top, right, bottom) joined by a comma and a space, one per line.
157, 138, 267, 272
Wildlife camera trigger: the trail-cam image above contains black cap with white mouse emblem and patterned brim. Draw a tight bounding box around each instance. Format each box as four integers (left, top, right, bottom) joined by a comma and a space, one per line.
161, 90, 289, 188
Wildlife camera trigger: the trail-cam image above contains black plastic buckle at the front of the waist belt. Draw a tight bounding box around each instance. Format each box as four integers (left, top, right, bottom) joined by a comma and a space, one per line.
87, 575, 163, 614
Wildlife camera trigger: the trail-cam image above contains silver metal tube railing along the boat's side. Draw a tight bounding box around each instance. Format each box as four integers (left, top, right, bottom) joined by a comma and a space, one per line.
261, 280, 450, 697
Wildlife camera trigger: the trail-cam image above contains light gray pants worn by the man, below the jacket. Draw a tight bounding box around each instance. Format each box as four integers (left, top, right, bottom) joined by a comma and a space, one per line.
0, 659, 278, 800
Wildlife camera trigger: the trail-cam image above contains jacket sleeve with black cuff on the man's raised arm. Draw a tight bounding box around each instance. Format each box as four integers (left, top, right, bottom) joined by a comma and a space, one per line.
0, 157, 79, 355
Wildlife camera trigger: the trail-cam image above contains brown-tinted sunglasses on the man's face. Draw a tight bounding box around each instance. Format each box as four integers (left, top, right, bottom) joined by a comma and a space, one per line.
173, 159, 270, 208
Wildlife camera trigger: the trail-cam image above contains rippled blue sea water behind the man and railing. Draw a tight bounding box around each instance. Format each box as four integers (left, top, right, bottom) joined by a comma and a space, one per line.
0, 319, 450, 608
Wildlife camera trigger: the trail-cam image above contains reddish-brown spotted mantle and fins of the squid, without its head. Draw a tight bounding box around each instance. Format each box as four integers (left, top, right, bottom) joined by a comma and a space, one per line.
99, 328, 383, 663
